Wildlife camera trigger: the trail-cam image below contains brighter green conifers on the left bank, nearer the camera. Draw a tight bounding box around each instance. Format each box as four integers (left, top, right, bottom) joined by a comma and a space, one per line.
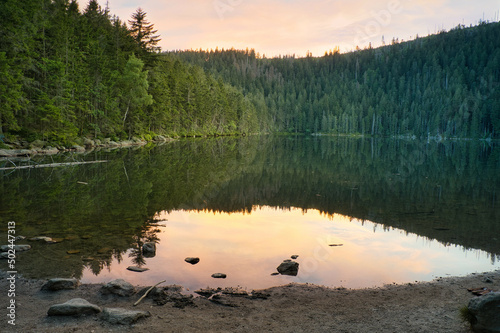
0, 0, 259, 144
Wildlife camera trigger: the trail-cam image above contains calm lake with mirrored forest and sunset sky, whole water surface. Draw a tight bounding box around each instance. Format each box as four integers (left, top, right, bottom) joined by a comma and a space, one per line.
0, 136, 500, 290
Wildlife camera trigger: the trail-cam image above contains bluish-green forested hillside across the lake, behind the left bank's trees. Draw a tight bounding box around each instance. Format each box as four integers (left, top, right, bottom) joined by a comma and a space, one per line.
177, 22, 500, 138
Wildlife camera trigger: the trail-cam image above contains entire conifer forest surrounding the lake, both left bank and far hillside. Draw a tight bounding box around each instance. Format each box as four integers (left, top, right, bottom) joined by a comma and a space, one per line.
0, 0, 500, 145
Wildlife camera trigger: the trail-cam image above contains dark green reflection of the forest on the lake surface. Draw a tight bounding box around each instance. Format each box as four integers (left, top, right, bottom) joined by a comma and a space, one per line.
0, 136, 500, 277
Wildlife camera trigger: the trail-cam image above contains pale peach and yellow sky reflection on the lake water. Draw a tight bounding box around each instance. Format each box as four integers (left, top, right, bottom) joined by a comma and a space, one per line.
82, 207, 500, 289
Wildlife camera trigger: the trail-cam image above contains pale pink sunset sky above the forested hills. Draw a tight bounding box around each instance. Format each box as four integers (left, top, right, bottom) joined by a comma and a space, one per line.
91, 0, 500, 58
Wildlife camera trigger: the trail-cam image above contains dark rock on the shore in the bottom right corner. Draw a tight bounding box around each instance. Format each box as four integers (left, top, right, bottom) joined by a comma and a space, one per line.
468, 292, 500, 333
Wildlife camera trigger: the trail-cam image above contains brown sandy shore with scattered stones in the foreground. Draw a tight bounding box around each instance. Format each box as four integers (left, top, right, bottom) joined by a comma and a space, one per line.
0, 270, 500, 333
